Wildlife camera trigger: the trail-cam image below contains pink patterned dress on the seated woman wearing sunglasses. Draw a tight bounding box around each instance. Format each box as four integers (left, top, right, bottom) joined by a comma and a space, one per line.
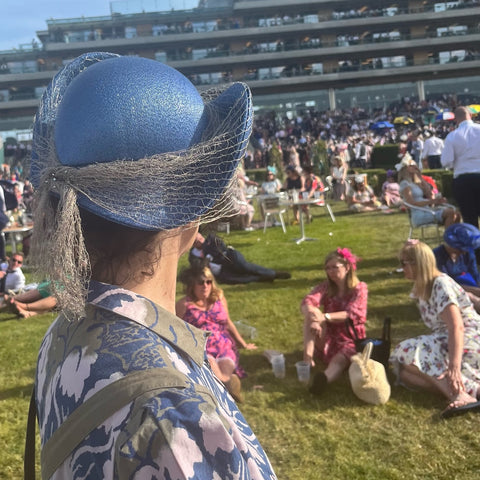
183, 299, 245, 378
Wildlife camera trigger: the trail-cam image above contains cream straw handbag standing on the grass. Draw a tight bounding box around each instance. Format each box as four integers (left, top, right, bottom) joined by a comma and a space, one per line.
348, 342, 390, 405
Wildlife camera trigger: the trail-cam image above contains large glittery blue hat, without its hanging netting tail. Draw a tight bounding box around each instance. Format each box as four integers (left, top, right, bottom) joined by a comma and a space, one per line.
31, 52, 252, 231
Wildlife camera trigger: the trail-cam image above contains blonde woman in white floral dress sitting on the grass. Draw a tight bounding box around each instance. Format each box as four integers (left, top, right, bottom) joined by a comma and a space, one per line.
390, 240, 480, 417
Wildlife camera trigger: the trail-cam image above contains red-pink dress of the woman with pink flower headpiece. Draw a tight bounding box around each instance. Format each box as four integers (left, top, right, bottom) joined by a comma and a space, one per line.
302, 281, 368, 363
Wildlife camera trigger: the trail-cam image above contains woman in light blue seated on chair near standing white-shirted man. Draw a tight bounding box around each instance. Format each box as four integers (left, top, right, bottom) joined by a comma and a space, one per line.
395, 153, 461, 227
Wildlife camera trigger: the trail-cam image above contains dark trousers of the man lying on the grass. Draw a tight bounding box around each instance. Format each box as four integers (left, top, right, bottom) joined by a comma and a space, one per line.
217, 248, 275, 284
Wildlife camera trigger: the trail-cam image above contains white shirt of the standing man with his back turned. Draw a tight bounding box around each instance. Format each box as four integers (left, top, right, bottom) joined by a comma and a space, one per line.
441, 120, 480, 178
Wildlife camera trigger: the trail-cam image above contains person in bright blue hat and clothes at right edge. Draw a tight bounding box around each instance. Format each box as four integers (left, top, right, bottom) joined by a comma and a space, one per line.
433, 223, 480, 312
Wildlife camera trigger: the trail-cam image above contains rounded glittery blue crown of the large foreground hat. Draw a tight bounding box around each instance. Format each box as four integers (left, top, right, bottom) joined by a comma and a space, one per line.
55, 57, 205, 166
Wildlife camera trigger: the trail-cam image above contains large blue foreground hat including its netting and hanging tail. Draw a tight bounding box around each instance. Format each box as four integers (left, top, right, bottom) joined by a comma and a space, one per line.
31, 52, 253, 317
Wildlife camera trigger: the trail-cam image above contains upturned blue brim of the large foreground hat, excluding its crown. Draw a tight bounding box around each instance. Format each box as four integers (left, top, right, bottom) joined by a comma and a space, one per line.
32, 52, 253, 231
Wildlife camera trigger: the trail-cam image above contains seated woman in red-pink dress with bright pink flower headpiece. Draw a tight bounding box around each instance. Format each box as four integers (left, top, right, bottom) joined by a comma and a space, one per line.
300, 248, 368, 394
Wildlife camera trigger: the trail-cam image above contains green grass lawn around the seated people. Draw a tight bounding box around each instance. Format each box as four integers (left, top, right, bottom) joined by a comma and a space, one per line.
0, 204, 480, 480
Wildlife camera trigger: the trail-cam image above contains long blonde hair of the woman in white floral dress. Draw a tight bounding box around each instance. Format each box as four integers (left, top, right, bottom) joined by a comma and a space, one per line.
398, 241, 441, 301
